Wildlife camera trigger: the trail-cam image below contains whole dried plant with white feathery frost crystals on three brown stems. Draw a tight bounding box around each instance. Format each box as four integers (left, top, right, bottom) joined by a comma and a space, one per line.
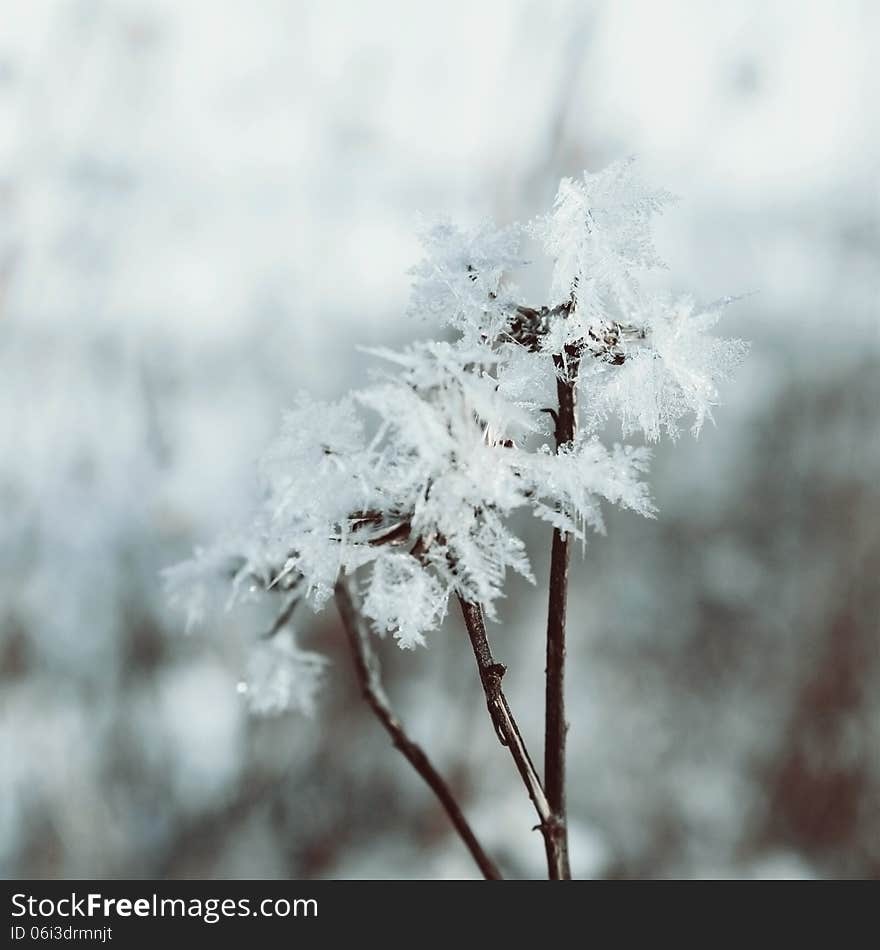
166, 161, 746, 878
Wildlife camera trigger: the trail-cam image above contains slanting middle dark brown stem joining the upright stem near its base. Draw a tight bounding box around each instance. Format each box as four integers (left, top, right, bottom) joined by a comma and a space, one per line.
458, 596, 558, 877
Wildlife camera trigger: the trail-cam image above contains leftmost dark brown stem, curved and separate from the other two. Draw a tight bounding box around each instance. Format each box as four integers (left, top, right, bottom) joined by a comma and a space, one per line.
336, 579, 501, 881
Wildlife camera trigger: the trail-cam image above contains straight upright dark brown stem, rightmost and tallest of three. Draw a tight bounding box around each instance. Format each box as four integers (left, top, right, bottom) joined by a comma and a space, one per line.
544, 351, 578, 881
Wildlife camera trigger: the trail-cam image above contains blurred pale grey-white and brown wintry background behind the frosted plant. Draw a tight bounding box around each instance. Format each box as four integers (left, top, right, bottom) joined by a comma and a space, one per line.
0, 0, 880, 878
